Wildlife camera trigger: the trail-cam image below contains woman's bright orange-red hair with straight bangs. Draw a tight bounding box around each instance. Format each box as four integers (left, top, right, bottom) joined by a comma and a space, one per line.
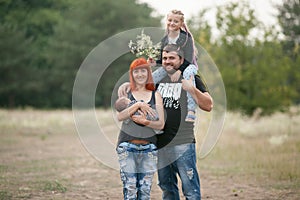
129, 58, 155, 91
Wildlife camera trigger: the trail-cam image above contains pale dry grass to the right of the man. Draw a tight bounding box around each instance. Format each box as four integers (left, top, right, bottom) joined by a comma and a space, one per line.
201, 108, 300, 188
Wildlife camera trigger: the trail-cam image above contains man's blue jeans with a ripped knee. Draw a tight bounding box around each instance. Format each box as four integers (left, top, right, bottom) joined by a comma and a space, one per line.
158, 143, 201, 200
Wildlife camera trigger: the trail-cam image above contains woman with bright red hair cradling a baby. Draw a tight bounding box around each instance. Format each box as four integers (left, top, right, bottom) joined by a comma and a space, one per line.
117, 58, 164, 199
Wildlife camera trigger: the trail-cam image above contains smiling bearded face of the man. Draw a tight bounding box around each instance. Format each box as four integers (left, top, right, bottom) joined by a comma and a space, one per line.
162, 51, 183, 74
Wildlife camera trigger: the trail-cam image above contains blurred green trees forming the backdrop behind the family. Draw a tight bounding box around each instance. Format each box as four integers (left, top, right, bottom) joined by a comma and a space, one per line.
0, 0, 300, 114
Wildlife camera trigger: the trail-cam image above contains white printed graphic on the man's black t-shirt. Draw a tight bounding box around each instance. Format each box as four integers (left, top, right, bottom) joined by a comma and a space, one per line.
157, 83, 182, 110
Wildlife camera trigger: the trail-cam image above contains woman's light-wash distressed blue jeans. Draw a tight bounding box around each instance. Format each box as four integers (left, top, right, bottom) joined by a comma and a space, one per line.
117, 142, 157, 200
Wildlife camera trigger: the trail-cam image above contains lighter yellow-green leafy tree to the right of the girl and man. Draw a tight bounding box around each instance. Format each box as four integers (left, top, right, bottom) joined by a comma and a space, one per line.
192, 2, 296, 115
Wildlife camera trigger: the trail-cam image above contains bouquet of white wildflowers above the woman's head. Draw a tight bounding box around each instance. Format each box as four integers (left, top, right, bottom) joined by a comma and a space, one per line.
128, 30, 161, 59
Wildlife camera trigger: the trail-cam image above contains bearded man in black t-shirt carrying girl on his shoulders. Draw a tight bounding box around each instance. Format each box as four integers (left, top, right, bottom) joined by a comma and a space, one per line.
153, 45, 213, 200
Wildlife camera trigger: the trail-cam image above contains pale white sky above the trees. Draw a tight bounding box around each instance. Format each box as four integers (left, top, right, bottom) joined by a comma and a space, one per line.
138, 0, 282, 26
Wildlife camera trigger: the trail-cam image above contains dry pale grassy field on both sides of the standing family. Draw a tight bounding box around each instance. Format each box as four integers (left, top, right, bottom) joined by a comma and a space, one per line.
0, 108, 300, 200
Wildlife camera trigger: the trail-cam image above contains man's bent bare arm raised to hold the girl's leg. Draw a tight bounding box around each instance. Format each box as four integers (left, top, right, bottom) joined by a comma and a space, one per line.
182, 77, 213, 112
